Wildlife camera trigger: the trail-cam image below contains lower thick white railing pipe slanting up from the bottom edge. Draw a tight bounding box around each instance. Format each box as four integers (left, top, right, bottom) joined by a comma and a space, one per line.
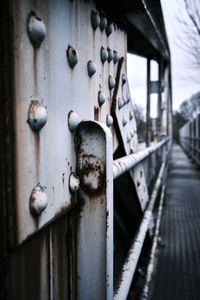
114, 162, 166, 300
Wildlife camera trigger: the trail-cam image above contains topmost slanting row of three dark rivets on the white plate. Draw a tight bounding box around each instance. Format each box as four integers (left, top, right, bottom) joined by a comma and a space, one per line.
91, 11, 113, 37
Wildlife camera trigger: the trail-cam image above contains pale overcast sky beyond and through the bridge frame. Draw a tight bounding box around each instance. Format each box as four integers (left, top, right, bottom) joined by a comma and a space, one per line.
127, 0, 200, 117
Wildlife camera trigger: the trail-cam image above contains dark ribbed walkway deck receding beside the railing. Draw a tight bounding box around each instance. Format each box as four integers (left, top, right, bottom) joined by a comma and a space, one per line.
151, 145, 200, 300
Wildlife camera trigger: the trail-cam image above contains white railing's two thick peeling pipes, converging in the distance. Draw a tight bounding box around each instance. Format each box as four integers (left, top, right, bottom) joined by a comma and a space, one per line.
113, 138, 171, 300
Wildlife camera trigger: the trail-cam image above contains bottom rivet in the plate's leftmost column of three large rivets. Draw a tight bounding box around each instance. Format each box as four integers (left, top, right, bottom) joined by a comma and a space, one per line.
30, 183, 48, 216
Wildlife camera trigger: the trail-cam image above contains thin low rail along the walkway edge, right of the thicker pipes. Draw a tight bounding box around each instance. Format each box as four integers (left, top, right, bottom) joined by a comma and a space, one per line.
140, 185, 165, 300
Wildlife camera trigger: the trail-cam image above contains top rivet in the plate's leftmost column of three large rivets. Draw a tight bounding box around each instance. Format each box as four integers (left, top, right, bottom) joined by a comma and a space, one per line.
28, 11, 46, 48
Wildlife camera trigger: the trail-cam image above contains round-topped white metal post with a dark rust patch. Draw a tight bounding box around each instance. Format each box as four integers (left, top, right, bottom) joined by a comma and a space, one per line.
74, 121, 113, 300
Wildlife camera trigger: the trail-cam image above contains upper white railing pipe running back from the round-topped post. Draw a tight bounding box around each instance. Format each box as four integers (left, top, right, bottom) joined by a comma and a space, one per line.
113, 137, 170, 179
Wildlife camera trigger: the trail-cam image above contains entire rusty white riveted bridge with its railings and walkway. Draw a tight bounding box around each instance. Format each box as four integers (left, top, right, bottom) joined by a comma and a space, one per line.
0, 0, 200, 300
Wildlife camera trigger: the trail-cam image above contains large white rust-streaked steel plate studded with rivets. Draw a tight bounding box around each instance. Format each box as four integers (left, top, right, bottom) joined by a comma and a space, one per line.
11, 0, 127, 245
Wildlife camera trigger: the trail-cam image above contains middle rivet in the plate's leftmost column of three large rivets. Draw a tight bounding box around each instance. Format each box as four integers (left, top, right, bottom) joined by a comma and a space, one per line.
27, 100, 47, 131
